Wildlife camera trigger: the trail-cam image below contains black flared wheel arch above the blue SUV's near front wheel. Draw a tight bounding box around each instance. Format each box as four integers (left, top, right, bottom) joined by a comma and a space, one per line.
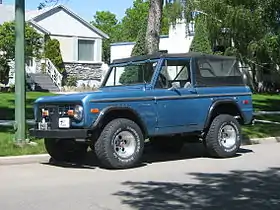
91, 106, 148, 137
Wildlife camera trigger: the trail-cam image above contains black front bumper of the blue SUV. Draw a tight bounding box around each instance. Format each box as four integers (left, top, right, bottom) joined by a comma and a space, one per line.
29, 128, 91, 139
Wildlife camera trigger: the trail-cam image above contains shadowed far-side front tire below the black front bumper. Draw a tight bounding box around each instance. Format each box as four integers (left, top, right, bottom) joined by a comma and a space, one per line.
44, 139, 88, 162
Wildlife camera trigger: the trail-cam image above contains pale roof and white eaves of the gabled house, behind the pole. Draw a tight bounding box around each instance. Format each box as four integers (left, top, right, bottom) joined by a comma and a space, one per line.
0, 4, 109, 39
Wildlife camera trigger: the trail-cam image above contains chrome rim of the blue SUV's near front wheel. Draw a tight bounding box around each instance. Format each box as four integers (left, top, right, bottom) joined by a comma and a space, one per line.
114, 131, 137, 158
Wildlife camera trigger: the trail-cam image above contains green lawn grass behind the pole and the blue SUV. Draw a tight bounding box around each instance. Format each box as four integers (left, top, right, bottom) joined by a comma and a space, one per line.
0, 92, 280, 156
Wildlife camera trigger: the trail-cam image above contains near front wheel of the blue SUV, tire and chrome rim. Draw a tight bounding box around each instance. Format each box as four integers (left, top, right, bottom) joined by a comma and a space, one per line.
95, 118, 144, 169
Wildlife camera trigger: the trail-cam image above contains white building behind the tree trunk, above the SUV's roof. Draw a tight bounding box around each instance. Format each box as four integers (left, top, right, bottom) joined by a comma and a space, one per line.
111, 20, 194, 61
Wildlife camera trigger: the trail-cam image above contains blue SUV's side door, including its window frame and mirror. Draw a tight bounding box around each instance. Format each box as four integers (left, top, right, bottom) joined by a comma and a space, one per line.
154, 58, 199, 132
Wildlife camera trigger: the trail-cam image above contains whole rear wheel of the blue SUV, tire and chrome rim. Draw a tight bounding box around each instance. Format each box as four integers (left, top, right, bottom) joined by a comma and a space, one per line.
204, 114, 242, 158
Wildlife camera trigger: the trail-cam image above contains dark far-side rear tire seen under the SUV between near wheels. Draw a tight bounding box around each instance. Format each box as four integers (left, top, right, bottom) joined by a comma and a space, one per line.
149, 136, 184, 153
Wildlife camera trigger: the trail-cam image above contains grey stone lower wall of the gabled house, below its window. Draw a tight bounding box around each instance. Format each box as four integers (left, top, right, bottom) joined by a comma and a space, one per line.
64, 63, 108, 86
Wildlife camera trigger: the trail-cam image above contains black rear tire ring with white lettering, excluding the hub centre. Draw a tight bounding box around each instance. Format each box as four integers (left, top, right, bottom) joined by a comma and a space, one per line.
204, 114, 242, 158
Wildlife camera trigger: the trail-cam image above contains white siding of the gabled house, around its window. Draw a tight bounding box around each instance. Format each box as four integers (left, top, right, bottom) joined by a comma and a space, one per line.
32, 9, 102, 63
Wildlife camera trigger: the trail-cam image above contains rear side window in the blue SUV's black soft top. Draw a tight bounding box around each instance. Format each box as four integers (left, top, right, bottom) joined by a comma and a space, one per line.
195, 57, 244, 86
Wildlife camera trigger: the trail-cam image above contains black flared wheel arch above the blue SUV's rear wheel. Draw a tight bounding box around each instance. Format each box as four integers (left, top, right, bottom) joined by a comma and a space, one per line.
204, 99, 244, 129
